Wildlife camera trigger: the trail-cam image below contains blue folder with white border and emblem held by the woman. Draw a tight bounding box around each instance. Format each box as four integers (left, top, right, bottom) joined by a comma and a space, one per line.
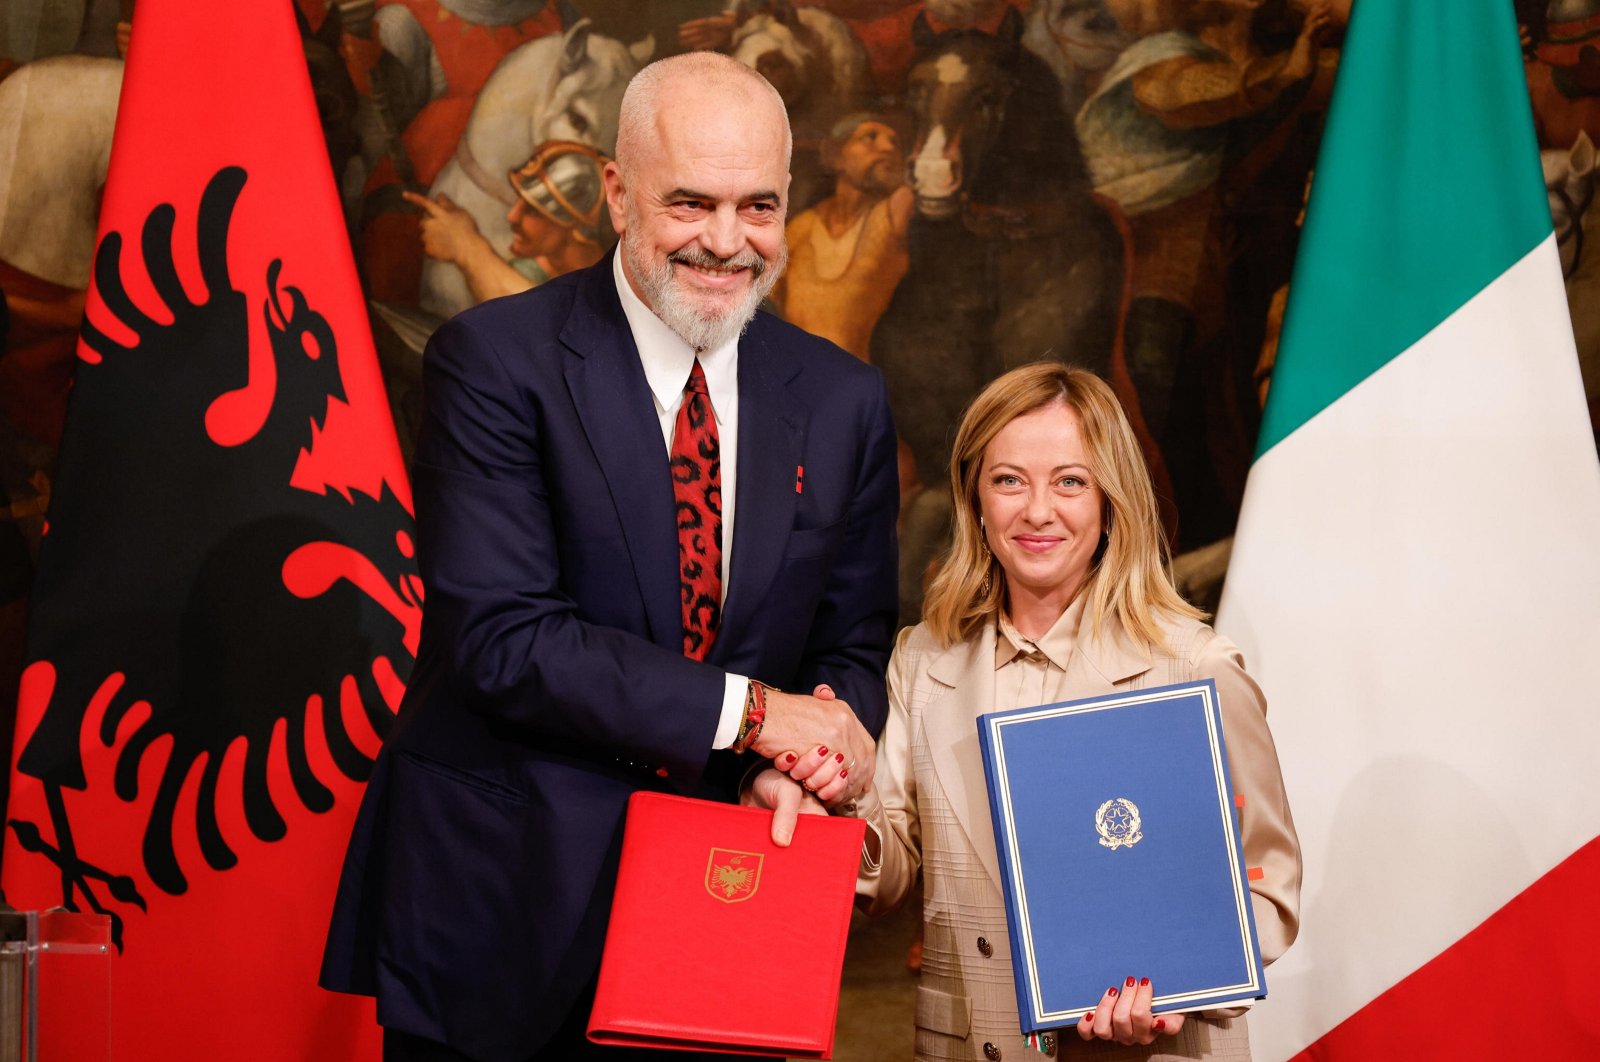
978, 680, 1267, 1033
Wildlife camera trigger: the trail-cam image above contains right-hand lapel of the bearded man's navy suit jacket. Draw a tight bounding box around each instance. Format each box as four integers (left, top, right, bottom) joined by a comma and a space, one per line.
710, 315, 805, 662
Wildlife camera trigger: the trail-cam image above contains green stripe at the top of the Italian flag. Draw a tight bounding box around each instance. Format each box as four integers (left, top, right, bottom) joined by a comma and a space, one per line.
1256, 0, 1550, 457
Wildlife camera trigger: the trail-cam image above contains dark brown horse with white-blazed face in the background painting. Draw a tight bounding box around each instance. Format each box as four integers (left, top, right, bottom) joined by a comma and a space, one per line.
872, 10, 1123, 622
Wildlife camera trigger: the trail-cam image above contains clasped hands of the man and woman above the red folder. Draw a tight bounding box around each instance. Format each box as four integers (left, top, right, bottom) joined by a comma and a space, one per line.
741, 685, 877, 848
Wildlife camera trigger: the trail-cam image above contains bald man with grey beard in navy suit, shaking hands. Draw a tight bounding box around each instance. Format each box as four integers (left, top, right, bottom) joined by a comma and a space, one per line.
322, 53, 896, 1062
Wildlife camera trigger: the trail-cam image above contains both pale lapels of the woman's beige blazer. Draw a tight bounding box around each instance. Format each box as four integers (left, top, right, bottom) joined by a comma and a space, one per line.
923, 619, 1150, 889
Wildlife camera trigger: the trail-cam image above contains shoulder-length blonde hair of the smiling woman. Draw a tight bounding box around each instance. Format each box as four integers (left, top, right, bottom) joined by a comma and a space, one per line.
923, 361, 1203, 651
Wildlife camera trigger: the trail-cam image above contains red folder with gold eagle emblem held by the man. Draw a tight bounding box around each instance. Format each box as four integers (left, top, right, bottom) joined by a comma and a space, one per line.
589, 792, 866, 1059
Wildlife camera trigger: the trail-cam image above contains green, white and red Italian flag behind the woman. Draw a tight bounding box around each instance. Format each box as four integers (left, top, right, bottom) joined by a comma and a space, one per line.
1218, 0, 1600, 1059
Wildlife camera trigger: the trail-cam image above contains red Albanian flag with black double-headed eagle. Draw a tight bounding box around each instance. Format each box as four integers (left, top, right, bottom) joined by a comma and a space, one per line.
3, 0, 421, 1062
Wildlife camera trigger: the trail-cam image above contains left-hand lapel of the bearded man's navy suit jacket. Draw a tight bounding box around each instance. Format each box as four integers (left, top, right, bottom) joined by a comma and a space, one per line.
562, 258, 683, 651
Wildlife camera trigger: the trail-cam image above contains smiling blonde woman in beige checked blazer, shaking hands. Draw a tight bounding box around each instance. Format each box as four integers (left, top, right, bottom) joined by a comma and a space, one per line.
752, 363, 1301, 1060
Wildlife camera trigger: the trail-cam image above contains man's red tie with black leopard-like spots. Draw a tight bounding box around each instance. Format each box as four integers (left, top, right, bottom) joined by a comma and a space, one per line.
672, 358, 722, 661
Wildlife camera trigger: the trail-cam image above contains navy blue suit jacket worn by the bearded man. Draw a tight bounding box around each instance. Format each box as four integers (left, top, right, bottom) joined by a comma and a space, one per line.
322, 252, 898, 1062
